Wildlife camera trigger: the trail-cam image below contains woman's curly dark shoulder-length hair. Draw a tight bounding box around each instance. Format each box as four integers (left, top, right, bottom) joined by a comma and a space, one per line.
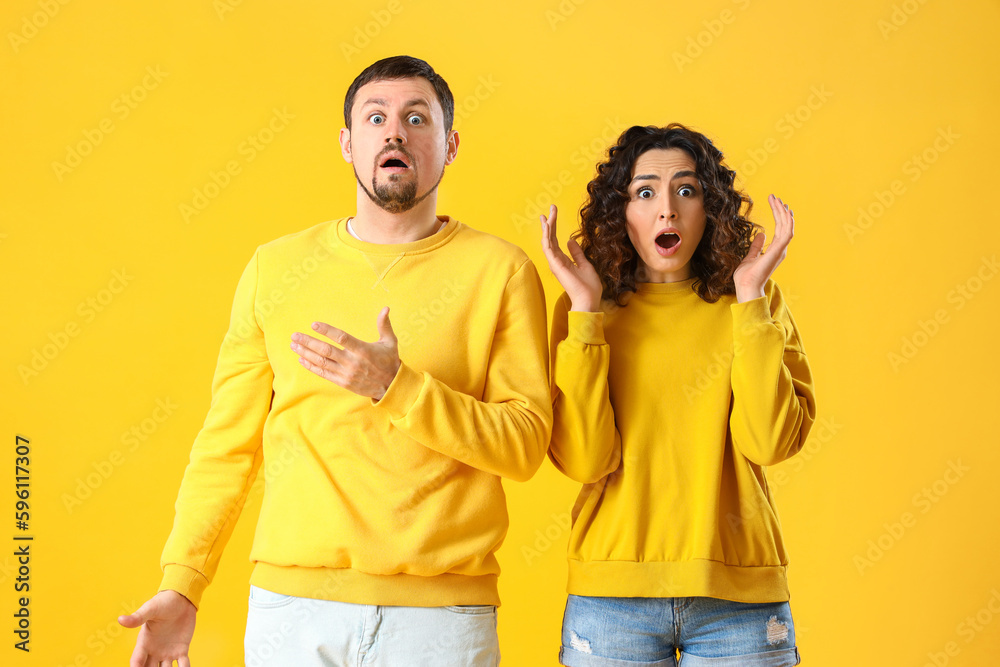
573, 123, 759, 305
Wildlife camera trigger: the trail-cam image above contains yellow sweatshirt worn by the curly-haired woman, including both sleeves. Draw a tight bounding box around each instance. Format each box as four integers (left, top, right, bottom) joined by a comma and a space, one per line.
549, 278, 816, 602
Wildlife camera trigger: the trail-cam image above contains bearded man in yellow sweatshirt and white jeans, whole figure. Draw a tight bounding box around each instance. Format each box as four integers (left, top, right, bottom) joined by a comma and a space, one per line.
119, 56, 552, 667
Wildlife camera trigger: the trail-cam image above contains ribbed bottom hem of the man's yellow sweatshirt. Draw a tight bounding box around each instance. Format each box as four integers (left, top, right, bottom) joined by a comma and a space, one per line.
250, 562, 500, 607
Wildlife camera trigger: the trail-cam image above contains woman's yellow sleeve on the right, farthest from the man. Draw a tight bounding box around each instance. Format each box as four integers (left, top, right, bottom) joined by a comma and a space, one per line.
729, 280, 816, 466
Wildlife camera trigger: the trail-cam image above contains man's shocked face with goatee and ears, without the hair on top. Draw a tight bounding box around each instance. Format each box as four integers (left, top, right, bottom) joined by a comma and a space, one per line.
340, 78, 458, 213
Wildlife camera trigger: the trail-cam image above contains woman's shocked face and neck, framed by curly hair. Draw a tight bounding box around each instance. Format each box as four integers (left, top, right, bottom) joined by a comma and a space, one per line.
625, 148, 705, 283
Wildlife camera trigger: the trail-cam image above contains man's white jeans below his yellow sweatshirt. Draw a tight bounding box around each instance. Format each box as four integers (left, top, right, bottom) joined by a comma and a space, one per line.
243, 586, 500, 667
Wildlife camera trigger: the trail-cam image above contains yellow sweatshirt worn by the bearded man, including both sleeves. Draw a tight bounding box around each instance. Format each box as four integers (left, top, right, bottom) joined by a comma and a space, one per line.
160, 217, 552, 606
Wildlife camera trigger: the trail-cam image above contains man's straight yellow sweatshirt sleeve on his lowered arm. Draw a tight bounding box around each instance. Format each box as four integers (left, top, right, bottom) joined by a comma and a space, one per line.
160, 249, 273, 607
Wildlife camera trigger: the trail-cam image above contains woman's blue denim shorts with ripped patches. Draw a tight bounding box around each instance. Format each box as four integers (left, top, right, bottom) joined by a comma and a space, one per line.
559, 595, 799, 667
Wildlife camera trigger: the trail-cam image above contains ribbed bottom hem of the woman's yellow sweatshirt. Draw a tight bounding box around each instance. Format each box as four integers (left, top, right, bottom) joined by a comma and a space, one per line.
566, 560, 788, 602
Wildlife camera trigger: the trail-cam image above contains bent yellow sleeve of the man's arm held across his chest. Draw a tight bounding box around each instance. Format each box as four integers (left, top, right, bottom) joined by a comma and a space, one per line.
373, 259, 552, 481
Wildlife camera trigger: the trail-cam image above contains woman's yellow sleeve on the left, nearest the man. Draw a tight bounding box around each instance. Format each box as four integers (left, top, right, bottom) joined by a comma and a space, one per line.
549, 294, 622, 484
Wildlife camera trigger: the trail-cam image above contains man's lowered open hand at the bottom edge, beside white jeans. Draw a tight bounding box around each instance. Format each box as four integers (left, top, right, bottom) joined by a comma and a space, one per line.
118, 591, 198, 667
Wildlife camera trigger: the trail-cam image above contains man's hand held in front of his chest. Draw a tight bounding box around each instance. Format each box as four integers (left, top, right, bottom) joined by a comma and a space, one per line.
292, 308, 400, 401
